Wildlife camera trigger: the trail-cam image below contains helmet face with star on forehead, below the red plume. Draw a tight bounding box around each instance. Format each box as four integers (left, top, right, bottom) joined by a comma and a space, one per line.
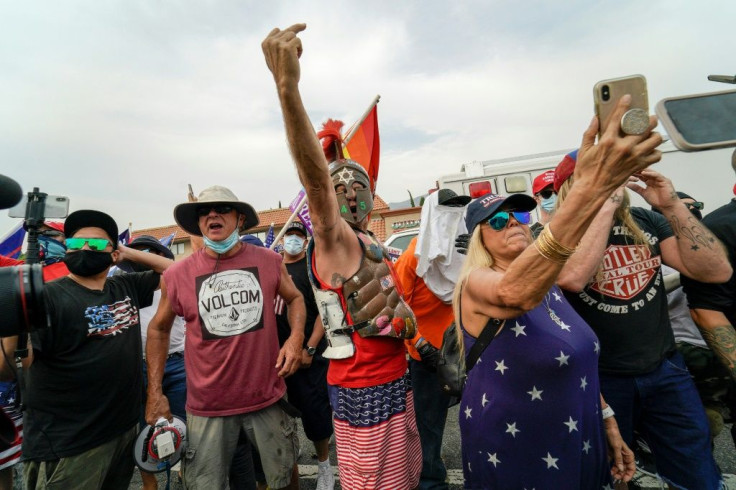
329, 159, 373, 224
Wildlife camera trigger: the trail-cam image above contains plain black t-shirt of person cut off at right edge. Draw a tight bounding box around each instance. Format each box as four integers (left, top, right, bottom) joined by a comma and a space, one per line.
680, 200, 736, 325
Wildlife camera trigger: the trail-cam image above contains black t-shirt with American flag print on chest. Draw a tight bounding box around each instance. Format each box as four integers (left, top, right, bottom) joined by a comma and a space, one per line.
23, 271, 159, 461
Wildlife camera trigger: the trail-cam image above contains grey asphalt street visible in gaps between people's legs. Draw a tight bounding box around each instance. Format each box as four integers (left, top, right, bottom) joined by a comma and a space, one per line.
130, 406, 736, 490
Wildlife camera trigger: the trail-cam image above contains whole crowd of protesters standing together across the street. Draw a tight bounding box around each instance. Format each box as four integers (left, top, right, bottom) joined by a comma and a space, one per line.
0, 24, 736, 490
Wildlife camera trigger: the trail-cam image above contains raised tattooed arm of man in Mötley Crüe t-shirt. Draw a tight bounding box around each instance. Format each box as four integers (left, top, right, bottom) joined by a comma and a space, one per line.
628, 170, 733, 283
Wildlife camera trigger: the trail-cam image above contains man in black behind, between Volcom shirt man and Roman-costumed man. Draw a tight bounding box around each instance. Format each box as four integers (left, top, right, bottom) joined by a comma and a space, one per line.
276, 221, 335, 490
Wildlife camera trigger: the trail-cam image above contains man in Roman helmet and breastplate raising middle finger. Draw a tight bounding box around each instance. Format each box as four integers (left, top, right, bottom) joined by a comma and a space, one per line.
262, 24, 421, 489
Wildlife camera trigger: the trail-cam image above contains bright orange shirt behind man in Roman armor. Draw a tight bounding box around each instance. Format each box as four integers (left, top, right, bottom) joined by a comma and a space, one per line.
394, 237, 455, 360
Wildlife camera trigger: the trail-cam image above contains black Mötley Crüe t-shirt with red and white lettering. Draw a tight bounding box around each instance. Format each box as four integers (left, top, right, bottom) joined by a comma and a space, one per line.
565, 208, 675, 375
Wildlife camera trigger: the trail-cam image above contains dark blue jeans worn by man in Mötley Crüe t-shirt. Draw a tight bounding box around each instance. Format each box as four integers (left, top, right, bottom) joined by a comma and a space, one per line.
600, 352, 721, 490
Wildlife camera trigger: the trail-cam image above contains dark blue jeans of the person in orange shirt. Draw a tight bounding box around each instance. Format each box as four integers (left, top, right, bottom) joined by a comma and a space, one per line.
409, 359, 450, 490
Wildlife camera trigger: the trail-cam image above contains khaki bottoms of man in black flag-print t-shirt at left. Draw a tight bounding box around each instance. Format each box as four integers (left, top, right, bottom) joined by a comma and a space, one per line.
23, 424, 138, 490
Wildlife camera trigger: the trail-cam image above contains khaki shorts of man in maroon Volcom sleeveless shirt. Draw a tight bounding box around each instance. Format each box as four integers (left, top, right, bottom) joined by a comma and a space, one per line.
182, 403, 299, 490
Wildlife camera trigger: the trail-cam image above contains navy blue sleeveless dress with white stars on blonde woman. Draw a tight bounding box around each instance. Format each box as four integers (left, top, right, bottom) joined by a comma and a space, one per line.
459, 286, 610, 490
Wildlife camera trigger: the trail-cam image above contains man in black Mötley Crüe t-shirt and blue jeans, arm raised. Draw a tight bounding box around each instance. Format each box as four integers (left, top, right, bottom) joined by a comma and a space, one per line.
552, 155, 731, 489
